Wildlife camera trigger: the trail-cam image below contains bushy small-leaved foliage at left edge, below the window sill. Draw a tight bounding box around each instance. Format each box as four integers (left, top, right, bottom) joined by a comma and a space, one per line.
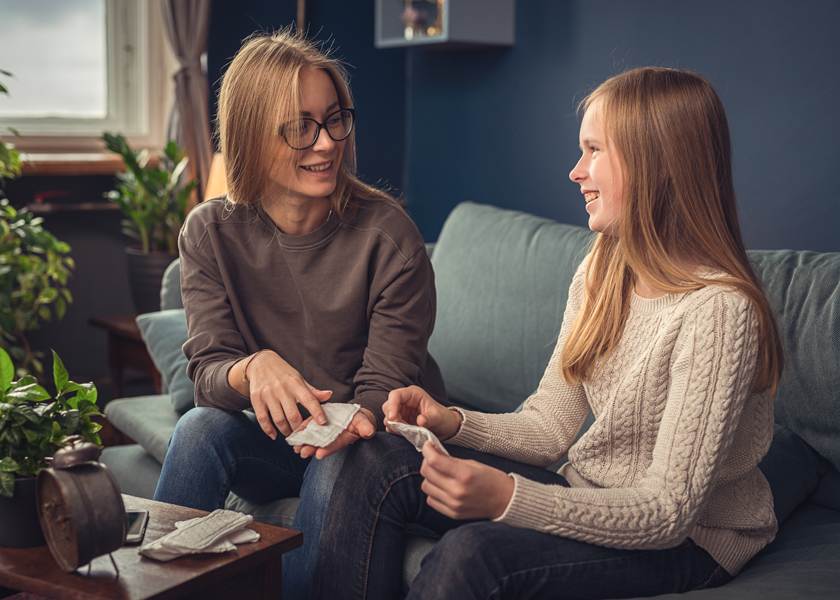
0, 198, 75, 376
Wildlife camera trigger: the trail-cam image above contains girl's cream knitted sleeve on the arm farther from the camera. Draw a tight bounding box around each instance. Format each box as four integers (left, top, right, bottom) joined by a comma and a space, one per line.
447, 259, 589, 467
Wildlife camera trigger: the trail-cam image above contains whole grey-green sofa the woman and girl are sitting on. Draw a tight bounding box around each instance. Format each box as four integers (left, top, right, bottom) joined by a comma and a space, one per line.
102, 203, 840, 600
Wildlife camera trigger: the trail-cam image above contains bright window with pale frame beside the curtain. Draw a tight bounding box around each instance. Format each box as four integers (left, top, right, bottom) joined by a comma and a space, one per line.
0, 0, 177, 153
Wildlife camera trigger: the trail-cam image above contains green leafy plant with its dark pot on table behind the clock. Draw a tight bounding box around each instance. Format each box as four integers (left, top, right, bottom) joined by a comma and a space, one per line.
0, 349, 102, 548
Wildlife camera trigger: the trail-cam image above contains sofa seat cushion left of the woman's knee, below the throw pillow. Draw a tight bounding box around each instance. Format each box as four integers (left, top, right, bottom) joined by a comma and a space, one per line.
105, 395, 181, 464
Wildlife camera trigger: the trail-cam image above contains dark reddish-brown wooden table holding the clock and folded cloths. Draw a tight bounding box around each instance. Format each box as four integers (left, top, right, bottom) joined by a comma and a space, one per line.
0, 495, 303, 600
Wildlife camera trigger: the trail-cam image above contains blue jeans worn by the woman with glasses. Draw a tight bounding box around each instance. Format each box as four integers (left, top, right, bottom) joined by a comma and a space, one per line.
155, 407, 344, 600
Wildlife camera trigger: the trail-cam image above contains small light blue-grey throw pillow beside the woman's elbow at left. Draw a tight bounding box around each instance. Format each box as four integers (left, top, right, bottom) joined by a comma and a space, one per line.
137, 308, 195, 413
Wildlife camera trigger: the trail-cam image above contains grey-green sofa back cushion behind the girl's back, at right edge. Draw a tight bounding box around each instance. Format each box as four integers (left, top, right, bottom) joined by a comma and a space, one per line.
750, 250, 840, 468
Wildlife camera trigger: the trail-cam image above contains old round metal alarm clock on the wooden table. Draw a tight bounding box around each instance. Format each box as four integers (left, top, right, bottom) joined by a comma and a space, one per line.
35, 435, 127, 571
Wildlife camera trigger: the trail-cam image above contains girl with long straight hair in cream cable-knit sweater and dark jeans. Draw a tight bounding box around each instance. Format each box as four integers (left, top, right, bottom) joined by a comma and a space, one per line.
311, 68, 784, 600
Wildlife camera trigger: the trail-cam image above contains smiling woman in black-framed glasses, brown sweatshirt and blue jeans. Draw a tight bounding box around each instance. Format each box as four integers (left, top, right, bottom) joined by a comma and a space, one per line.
155, 31, 445, 598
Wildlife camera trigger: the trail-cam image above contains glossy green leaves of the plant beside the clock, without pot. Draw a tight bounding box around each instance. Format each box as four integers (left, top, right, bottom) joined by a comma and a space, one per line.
0, 349, 102, 498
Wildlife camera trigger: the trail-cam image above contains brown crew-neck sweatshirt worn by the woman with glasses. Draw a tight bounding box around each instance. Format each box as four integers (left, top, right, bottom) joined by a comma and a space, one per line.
179, 198, 446, 429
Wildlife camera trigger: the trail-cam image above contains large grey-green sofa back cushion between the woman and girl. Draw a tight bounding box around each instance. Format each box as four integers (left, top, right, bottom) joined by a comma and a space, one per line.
429, 202, 591, 412
